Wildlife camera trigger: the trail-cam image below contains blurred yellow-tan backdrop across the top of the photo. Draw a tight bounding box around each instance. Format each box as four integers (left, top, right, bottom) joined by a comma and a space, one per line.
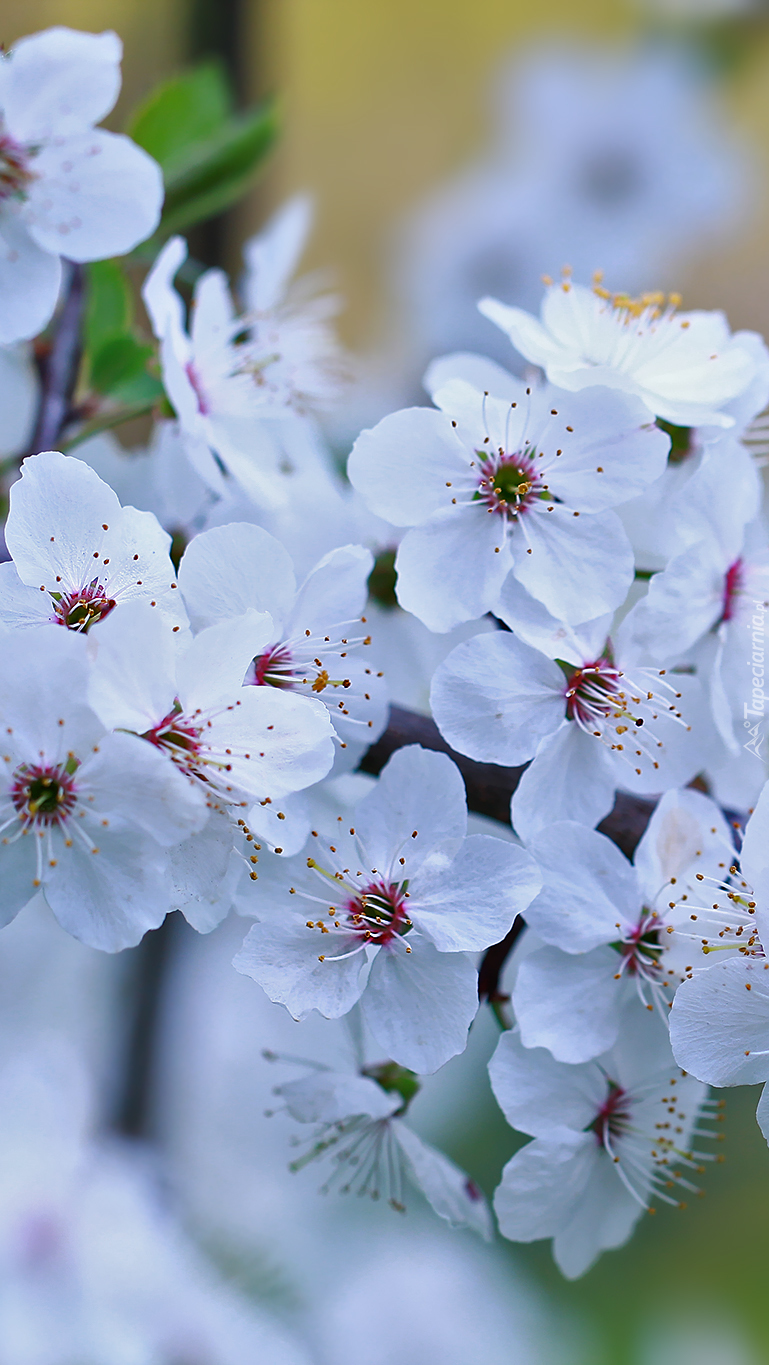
1, 0, 769, 345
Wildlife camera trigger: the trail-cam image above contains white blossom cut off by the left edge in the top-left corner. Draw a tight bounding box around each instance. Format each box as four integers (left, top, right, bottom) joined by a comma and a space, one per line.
0, 27, 163, 343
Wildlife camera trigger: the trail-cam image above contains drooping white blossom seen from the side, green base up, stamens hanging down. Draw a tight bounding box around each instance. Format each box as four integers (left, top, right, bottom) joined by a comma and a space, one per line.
269, 1062, 492, 1241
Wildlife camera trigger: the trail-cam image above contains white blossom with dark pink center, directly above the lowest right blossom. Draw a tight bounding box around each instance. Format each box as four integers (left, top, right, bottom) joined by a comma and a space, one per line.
512, 789, 750, 1063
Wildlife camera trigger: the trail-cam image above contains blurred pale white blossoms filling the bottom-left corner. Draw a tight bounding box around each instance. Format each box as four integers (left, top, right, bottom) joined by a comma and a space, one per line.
0, 1039, 315, 1365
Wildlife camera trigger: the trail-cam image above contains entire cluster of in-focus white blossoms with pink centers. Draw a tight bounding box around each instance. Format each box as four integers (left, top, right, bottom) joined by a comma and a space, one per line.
0, 30, 769, 1294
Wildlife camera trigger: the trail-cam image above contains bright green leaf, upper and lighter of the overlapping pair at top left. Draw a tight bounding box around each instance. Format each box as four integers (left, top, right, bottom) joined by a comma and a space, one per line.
127, 61, 232, 172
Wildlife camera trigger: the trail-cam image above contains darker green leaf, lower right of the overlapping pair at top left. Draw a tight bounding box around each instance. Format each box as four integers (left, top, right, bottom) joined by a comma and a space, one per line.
158, 101, 277, 236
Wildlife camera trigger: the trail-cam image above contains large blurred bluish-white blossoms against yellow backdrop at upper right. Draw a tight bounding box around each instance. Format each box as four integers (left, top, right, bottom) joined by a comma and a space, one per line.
391, 46, 750, 379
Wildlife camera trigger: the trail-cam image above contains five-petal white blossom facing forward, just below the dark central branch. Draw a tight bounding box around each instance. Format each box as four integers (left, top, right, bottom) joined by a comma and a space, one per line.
235, 745, 540, 1073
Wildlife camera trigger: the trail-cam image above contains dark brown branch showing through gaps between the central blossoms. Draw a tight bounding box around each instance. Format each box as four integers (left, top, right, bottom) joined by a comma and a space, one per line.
361, 706, 654, 1005
